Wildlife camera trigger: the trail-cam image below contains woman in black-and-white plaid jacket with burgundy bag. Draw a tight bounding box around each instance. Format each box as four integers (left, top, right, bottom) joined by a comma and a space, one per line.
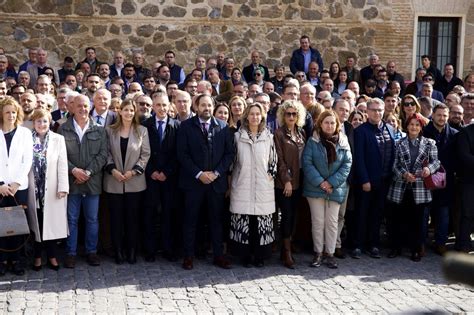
387, 113, 440, 261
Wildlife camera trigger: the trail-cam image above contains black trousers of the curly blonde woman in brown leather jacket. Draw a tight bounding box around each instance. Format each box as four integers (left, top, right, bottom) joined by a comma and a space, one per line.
275, 188, 301, 238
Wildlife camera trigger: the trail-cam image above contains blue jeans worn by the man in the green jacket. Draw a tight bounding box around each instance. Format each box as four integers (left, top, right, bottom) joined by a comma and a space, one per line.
66, 194, 99, 256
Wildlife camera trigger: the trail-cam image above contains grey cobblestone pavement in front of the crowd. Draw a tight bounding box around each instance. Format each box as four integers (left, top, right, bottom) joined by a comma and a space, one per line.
0, 254, 474, 315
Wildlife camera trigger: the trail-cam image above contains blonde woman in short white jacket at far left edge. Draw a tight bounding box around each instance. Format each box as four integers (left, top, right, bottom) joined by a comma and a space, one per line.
0, 97, 33, 276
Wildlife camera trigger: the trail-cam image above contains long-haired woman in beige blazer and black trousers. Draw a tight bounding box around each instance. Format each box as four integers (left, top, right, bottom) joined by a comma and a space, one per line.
104, 100, 150, 264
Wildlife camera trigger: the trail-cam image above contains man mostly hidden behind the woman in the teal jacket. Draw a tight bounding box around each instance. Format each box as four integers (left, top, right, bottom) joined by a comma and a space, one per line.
333, 98, 354, 258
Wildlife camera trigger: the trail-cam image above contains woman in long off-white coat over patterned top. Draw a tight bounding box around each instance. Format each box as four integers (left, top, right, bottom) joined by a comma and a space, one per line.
28, 109, 69, 271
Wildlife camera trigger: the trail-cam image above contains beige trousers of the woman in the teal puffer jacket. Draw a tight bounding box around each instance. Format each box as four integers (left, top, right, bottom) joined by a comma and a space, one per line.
307, 197, 341, 255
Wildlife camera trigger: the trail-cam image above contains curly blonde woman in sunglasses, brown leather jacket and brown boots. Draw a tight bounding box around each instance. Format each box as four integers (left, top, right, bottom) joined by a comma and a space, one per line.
275, 100, 306, 269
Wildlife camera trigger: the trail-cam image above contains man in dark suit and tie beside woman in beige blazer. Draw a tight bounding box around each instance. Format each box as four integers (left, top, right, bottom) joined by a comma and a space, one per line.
142, 92, 179, 262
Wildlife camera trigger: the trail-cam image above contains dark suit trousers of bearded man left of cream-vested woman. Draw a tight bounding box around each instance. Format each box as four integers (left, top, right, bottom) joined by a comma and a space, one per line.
183, 185, 224, 257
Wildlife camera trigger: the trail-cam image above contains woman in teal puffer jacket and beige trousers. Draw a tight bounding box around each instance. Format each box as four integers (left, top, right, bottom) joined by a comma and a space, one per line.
303, 110, 352, 268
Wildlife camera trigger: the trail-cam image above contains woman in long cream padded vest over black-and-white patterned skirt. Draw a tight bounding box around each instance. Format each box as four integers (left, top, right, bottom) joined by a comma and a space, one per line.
230, 103, 277, 267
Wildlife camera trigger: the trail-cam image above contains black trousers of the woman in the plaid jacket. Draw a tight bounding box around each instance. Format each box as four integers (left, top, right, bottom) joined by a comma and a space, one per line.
389, 190, 428, 253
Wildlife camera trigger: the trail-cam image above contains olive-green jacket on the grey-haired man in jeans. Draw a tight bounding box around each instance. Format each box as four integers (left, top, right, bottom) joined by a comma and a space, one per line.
58, 117, 107, 195
